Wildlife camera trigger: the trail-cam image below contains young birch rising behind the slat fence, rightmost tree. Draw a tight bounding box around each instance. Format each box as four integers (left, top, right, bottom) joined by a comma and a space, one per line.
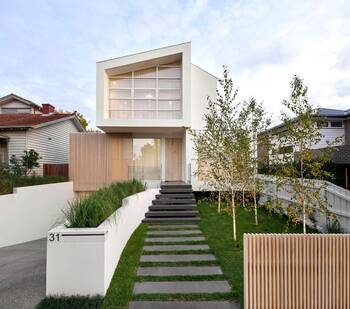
276, 76, 329, 233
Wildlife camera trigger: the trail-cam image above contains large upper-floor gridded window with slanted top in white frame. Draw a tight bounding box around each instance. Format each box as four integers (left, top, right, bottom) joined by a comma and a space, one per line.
109, 63, 182, 119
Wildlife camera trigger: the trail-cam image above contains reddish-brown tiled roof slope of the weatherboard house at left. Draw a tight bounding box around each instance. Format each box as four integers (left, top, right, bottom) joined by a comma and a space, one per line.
0, 113, 73, 127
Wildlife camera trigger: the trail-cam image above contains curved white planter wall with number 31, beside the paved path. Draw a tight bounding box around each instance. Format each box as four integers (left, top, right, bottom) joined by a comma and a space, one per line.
46, 189, 159, 296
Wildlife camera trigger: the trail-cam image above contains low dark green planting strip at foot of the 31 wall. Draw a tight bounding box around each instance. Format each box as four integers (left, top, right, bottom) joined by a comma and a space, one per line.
36, 296, 103, 309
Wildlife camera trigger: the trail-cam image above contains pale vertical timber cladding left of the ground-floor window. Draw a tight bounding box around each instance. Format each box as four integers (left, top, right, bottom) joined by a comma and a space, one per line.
69, 133, 132, 191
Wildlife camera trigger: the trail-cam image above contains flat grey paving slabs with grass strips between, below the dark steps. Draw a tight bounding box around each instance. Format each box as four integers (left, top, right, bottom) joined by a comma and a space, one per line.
129, 224, 239, 309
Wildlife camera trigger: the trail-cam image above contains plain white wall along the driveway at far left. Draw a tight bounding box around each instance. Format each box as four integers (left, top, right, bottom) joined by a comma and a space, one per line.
0, 182, 74, 248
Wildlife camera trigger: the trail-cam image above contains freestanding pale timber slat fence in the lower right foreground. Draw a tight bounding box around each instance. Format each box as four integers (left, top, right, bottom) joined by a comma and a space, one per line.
244, 234, 350, 309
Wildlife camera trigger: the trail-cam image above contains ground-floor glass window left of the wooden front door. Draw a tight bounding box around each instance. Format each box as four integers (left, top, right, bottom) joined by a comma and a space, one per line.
132, 138, 161, 180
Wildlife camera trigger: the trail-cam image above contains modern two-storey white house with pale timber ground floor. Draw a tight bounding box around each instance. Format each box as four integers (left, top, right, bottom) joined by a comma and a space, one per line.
70, 43, 217, 191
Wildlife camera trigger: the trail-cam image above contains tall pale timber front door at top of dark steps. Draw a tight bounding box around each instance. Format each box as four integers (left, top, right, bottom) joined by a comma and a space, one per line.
165, 138, 182, 181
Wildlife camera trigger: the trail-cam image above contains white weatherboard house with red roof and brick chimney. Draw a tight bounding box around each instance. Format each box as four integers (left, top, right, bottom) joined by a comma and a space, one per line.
0, 94, 84, 175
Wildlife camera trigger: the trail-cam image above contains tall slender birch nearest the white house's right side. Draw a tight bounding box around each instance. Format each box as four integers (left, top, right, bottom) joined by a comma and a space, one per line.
191, 67, 250, 240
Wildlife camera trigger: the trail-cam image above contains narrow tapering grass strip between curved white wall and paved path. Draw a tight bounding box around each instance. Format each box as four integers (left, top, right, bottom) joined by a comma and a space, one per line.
102, 224, 147, 309
